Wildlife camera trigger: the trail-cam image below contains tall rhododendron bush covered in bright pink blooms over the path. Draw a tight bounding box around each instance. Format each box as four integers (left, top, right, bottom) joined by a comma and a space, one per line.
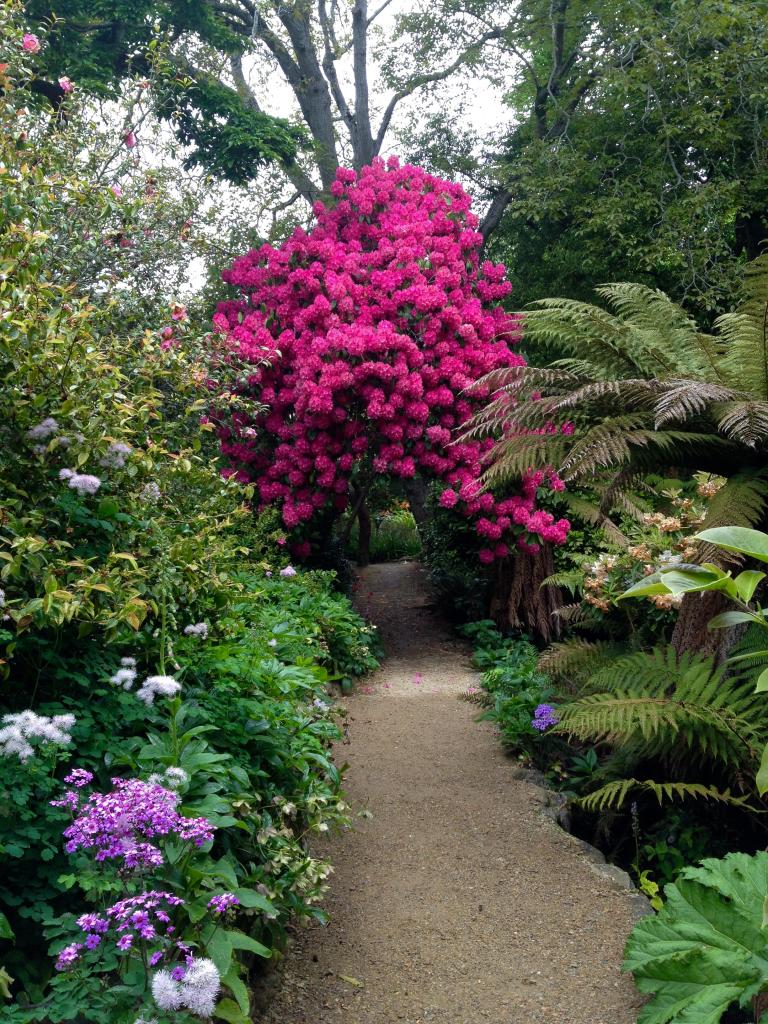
214, 158, 568, 562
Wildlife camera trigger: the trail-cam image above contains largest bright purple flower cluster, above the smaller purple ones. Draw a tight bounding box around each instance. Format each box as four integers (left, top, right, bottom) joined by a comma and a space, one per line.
58, 778, 213, 869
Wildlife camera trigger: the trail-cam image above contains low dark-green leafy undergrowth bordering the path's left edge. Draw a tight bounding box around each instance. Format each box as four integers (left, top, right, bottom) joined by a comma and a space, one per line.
0, 571, 377, 1024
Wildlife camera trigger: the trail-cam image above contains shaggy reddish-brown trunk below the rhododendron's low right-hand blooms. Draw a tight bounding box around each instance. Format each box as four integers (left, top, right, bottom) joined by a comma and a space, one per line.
490, 545, 563, 643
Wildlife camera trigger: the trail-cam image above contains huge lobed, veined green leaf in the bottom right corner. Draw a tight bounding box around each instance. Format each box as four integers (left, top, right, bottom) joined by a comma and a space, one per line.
624, 853, 768, 1024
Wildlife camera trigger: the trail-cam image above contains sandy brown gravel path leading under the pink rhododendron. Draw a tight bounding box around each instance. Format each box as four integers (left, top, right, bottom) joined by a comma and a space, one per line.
263, 563, 638, 1024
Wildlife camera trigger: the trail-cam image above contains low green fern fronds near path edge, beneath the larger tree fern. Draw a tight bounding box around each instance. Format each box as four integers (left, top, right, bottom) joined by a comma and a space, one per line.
544, 642, 768, 809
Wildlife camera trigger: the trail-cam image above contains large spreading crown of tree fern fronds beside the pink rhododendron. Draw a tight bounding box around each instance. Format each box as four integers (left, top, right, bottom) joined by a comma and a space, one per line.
465, 257, 768, 512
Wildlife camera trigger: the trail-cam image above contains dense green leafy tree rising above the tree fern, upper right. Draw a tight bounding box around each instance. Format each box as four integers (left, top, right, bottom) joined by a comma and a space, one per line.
403, 0, 768, 314
